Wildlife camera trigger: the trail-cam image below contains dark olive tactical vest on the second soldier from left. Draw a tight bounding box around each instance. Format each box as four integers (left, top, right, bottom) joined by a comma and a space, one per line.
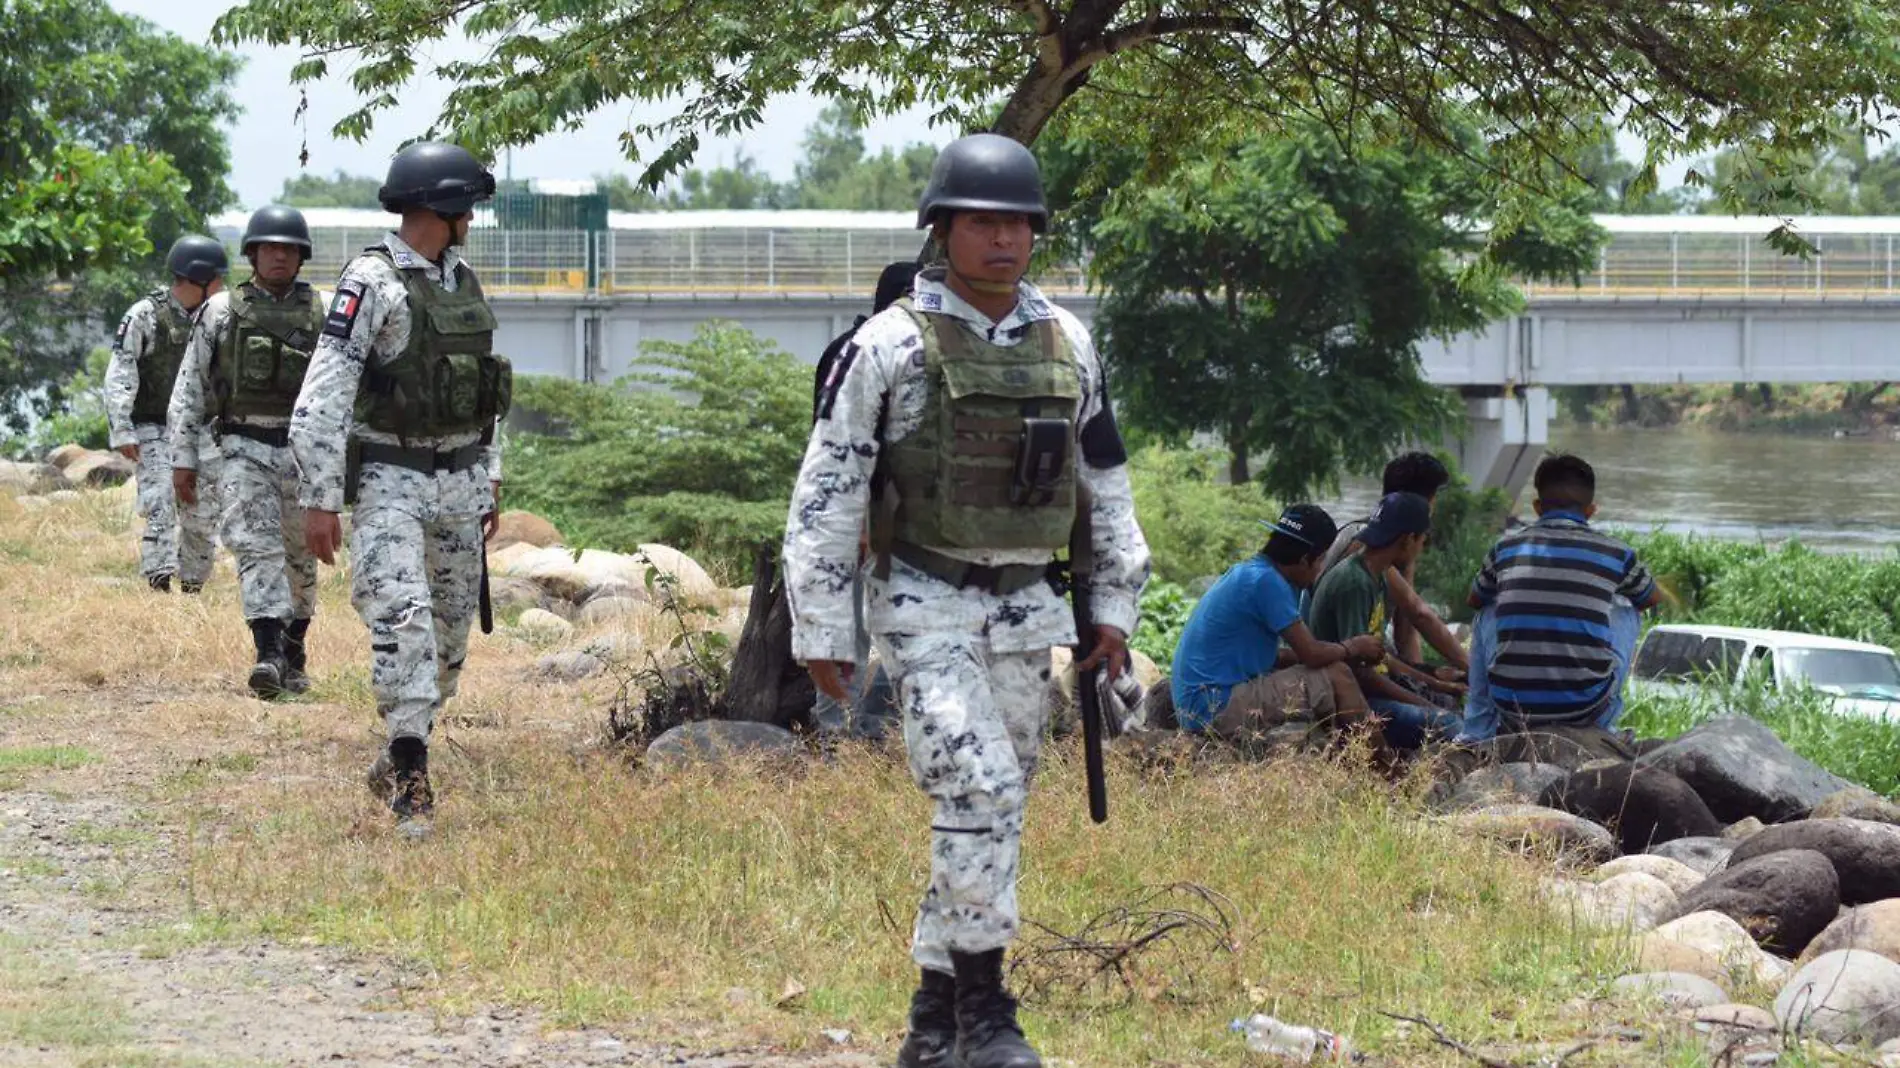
213, 281, 323, 420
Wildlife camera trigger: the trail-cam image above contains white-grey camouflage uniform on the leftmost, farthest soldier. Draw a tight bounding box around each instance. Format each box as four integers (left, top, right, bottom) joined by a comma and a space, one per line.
106, 293, 222, 589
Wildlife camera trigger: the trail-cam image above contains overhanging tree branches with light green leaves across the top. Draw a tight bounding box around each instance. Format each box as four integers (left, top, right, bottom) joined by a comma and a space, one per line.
215, 0, 1900, 236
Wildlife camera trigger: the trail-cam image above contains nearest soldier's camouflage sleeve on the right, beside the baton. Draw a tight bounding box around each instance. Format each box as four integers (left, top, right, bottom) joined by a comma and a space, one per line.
1056, 310, 1151, 635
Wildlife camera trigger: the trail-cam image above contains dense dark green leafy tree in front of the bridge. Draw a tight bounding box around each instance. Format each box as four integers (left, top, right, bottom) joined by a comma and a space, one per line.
1045, 114, 1602, 500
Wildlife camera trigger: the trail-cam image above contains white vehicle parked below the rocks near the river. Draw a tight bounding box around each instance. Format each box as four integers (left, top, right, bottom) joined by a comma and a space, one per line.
1630, 623, 1900, 722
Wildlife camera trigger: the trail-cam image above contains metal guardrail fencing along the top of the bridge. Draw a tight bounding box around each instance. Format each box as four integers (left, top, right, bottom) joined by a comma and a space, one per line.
288, 228, 1900, 302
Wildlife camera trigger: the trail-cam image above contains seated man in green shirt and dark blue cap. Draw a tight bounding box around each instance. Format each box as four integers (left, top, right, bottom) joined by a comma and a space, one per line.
1305, 494, 1457, 749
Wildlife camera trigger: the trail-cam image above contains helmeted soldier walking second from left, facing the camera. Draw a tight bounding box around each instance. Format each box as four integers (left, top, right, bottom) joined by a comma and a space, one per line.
171, 205, 323, 699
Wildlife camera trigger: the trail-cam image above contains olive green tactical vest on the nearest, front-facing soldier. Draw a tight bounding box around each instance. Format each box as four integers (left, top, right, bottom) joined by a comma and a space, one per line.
872, 298, 1081, 549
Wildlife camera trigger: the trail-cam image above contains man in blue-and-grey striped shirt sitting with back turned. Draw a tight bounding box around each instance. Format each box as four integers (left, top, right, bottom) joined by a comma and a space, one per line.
1457, 456, 1659, 743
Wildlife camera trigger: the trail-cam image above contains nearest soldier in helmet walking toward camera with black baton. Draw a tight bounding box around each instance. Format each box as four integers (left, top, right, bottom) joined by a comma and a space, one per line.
785, 133, 1148, 1068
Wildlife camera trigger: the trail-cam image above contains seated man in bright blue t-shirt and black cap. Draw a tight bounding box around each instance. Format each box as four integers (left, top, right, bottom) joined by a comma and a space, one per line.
1172, 504, 1385, 741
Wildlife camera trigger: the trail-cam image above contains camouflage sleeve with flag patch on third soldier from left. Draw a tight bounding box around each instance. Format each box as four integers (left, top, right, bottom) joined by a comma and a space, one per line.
291, 257, 389, 511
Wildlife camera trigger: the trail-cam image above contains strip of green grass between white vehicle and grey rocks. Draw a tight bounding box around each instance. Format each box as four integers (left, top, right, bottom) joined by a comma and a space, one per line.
1619, 682, 1900, 796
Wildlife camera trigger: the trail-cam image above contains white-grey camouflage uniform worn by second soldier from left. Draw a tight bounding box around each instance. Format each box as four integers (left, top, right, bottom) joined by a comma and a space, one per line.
169, 287, 323, 621
